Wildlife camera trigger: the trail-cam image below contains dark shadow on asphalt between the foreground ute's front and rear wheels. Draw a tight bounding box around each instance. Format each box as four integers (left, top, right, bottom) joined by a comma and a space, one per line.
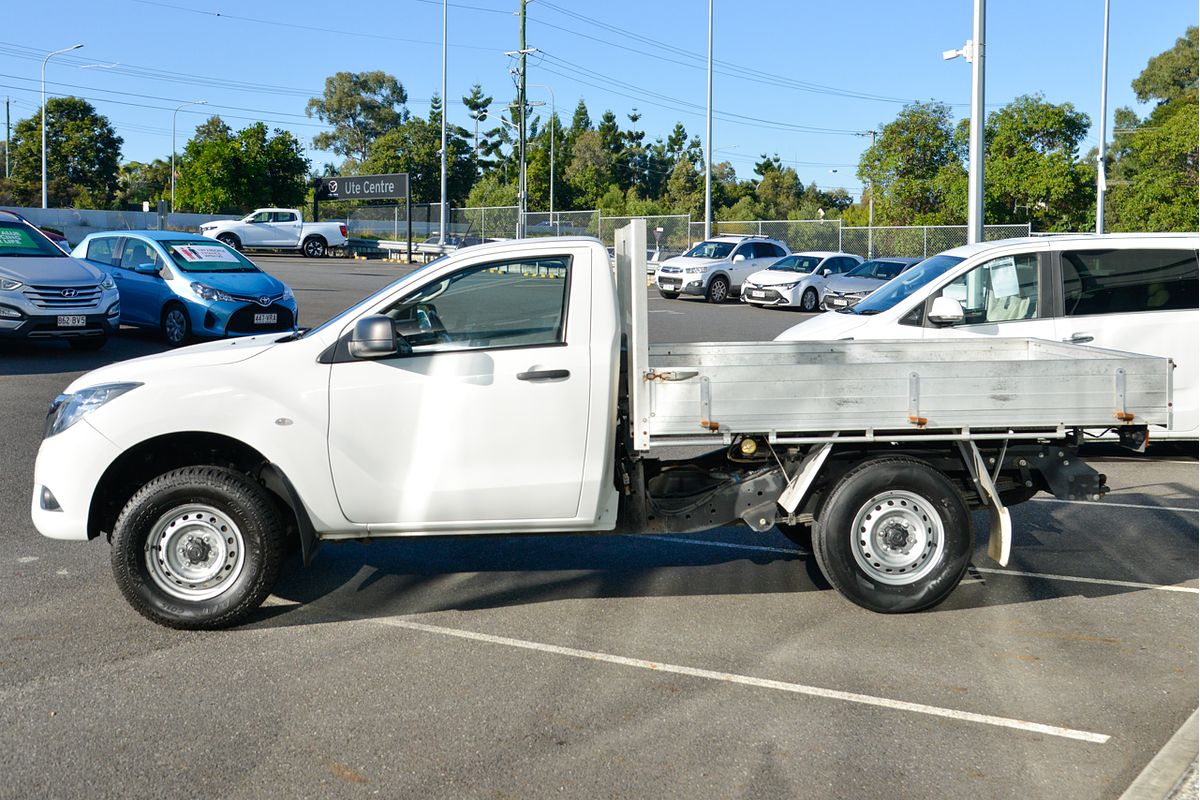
254, 530, 830, 625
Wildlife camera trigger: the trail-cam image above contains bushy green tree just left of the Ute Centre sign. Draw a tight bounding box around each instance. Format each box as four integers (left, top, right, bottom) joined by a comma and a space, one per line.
175, 116, 308, 213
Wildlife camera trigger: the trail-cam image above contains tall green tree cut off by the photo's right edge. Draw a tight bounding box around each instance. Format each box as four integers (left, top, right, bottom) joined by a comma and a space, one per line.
1105, 26, 1200, 231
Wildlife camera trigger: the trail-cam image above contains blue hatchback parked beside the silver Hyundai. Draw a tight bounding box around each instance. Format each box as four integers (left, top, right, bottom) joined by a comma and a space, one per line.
71, 230, 298, 345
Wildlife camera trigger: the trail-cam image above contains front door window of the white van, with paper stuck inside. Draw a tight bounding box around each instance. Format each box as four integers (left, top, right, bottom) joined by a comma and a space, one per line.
942, 254, 1039, 325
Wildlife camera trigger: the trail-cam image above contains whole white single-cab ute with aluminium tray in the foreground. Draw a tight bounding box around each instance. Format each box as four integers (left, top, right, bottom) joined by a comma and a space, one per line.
32, 223, 1171, 628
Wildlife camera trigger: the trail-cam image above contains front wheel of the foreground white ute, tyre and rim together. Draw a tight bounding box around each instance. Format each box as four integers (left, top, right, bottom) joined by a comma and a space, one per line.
112, 467, 283, 630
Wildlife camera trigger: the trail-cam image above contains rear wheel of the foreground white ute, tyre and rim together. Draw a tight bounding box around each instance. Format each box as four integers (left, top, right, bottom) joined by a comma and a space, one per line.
812, 456, 974, 614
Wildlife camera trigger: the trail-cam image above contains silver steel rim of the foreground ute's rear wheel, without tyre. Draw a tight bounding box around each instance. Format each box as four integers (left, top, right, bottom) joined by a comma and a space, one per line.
851, 489, 946, 587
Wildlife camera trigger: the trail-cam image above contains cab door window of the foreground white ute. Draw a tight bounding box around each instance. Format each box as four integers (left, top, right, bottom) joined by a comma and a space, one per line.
383, 255, 571, 353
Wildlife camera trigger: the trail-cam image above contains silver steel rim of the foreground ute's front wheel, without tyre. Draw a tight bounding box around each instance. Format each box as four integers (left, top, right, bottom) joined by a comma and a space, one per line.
144, 503, 246, 602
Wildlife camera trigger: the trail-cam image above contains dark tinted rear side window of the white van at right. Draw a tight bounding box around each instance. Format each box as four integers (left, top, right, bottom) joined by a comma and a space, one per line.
1062, 249, 1200, 317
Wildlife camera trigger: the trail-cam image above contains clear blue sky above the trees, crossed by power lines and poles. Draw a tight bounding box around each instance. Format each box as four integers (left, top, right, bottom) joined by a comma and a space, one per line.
0, 0, 1198, 199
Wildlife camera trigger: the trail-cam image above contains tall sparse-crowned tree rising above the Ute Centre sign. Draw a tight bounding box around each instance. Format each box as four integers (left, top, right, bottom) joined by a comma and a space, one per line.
305, 70, 408, 168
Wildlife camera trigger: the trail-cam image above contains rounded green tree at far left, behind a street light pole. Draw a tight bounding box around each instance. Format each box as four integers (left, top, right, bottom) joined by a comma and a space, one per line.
11, 97, 124, 209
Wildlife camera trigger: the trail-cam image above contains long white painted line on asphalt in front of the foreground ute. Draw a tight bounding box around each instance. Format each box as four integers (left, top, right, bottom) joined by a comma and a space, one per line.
365, 616, 1110, 745
